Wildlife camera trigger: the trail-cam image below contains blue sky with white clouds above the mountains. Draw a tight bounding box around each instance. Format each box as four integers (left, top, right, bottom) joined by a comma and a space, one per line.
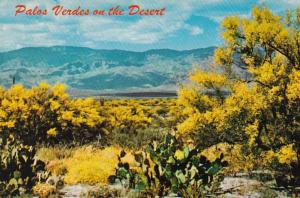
0, 0, 300, 51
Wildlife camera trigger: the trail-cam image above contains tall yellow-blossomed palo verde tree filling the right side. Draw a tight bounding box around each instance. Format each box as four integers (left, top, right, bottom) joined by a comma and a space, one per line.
177, 7, 300, 181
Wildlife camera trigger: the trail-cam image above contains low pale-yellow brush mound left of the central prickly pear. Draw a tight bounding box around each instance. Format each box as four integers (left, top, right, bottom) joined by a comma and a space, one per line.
59, 146, 133, 185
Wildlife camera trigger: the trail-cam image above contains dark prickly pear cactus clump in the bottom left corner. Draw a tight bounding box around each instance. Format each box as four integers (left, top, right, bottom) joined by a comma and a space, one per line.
0, 136, 47, 197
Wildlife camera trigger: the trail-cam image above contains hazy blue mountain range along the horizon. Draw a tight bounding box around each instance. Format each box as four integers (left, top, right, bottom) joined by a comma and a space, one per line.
0, 46, 215, 94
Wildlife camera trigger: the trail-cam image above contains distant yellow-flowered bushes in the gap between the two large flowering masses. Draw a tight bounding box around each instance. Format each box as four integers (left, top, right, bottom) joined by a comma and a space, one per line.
98, 99, 169, 133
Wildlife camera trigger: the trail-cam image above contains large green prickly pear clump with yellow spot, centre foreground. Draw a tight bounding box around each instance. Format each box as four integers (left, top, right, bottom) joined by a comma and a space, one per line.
147, 134, 227, 197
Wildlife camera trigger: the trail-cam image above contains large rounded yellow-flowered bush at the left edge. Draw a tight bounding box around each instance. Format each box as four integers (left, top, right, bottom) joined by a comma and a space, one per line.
0, 83, 103, 145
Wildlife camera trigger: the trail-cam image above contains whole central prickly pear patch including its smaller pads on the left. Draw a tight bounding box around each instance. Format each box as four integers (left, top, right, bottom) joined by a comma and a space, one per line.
110, 134, 227, 197
